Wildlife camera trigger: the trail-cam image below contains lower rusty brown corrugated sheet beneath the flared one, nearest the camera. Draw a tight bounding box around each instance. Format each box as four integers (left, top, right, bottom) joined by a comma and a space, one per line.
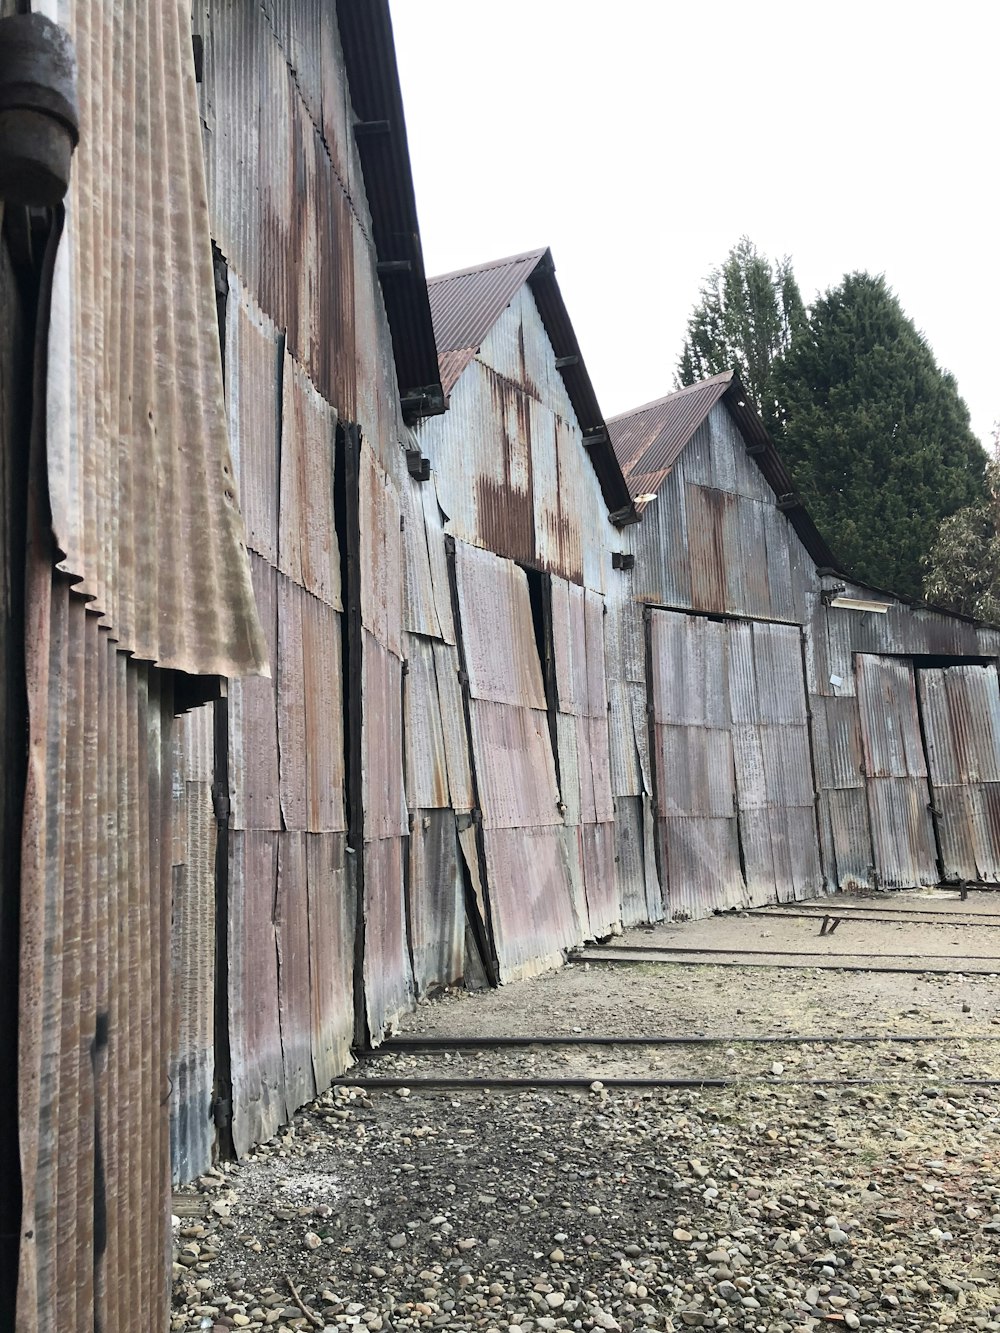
16, 573, 173, 1333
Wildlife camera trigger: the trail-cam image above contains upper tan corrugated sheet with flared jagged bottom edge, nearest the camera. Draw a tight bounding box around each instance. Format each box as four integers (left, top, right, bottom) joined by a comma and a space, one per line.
47, 0, 267, 676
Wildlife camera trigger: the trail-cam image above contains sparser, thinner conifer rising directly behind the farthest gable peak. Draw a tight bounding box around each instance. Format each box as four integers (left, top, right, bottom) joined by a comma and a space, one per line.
677, 236, 805, 428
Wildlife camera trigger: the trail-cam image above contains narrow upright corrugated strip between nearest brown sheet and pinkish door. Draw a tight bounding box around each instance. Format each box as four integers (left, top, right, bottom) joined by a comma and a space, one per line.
168, 709, 217, 1181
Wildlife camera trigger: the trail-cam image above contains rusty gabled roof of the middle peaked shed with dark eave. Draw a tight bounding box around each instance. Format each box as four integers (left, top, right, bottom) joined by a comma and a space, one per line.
428, 249, 639, 527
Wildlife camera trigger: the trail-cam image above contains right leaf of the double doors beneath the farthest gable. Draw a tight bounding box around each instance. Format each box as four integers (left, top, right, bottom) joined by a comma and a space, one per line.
728, 621, 823, 905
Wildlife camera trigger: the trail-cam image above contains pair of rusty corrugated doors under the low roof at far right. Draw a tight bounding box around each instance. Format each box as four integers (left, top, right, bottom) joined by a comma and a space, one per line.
855, 653, 1000, 888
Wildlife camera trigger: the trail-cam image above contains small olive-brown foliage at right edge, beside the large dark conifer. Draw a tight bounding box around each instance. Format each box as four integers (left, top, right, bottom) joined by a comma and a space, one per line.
924, 437, 1000, 625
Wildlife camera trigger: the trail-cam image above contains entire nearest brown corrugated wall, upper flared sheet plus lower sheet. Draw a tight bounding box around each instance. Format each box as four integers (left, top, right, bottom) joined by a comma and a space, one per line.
16, 0, 267, 1333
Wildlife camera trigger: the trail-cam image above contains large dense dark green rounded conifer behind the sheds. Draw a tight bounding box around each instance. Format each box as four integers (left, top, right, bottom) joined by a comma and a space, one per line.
773, 273, 988, 597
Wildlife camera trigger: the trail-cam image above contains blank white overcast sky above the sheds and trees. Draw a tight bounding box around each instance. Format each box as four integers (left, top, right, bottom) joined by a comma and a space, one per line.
392, 0, 1000, 441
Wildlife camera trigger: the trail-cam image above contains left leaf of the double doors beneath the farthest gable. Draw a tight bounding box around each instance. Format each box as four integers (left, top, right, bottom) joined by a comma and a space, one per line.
649, 611, 747, 921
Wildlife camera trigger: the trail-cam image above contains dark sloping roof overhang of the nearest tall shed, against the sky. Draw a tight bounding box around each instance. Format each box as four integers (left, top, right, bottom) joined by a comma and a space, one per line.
337, 0, 445, 421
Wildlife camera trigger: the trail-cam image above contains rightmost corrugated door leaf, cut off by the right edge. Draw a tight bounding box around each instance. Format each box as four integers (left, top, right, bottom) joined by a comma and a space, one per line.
917, 665, 1000, 884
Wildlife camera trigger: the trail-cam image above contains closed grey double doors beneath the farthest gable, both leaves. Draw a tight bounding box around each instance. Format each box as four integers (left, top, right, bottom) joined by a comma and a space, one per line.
648, 611, 823, 920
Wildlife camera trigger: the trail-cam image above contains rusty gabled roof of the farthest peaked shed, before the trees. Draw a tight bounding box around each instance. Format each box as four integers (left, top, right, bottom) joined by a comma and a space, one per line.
608, 371, 843, 573
